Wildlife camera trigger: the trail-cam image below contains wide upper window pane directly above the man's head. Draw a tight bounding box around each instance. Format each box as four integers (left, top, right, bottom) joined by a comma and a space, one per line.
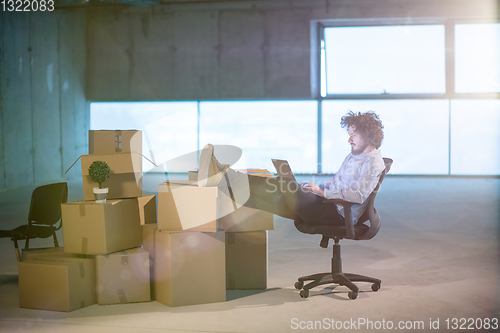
324, 25, 446, 95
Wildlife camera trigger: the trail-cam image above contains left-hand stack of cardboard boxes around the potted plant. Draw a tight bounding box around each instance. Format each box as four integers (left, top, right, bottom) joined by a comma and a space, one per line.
19, 131, 156, 311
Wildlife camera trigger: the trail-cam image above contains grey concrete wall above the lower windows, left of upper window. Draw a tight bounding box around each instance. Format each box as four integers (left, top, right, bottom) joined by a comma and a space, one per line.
86, 0, 497, 101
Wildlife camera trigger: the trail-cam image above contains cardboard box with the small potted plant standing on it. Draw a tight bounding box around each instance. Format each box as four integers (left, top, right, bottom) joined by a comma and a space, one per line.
61, 199, 142, 254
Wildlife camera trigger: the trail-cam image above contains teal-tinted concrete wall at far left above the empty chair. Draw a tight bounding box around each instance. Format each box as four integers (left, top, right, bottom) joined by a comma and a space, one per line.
0, 10, 89, 189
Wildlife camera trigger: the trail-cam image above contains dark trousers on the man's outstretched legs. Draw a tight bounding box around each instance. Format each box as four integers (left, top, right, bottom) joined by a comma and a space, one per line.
236, 175, 345, 226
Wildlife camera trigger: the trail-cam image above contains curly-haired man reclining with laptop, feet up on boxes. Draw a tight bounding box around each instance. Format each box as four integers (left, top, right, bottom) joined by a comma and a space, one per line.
198, 111, 385, 225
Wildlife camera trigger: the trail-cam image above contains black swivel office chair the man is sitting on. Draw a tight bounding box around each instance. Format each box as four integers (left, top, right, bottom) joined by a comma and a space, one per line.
295, 158, 392, 299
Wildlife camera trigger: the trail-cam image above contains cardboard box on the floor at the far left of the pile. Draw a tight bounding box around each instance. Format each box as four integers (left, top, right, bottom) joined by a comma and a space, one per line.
18, 257, 96, 311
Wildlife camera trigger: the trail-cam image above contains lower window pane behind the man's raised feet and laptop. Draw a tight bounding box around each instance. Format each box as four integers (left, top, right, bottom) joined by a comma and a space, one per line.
200, 101, 318, 173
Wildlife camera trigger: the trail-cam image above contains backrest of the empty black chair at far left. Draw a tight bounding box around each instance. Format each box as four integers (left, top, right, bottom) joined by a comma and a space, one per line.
28, 182, 68, 225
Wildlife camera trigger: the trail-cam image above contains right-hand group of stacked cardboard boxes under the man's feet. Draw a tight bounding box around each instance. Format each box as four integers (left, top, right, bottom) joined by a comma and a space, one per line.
149, 172, 274, 306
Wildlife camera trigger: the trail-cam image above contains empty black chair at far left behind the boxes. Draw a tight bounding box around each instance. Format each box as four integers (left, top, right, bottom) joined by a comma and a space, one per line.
0, 182, 68, 261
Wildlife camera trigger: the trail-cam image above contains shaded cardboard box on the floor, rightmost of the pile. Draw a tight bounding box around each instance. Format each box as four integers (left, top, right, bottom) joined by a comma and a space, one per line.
226, 231, 267, 290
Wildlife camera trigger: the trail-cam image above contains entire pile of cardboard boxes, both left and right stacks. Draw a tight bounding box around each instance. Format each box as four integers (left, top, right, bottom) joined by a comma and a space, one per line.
19, 131, 273, 311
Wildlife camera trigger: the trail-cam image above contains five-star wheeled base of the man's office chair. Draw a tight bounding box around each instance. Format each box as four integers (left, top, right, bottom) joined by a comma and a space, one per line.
295, 272, 382, 299
